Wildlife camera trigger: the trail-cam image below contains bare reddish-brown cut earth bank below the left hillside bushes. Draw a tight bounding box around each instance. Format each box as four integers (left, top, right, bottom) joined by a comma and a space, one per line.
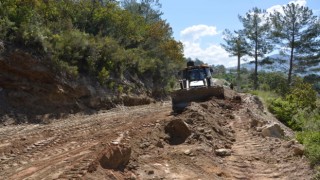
0, 46, 159, 124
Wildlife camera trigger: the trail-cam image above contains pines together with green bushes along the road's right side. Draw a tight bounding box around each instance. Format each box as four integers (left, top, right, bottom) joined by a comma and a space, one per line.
219, 3, 320, 174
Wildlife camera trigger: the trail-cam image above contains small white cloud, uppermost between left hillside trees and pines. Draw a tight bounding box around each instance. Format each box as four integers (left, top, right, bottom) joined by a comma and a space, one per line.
180, 24, 219, 41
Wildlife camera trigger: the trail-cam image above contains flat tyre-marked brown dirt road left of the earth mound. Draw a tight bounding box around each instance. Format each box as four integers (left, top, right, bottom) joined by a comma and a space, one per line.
0, 104, 170, 179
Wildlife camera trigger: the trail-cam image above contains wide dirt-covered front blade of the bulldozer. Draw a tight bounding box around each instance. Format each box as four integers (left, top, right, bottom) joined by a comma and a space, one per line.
171, 86, 224, 112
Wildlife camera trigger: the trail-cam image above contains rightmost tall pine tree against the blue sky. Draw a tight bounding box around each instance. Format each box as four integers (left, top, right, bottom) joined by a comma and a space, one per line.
270, 3, 320, 85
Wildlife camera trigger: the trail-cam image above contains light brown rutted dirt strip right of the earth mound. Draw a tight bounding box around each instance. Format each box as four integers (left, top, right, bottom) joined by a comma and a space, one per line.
225, 110, 308, 180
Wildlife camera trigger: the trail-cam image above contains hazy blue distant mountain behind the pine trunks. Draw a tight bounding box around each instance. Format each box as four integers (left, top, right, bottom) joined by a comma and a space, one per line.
228, 54, 320, 76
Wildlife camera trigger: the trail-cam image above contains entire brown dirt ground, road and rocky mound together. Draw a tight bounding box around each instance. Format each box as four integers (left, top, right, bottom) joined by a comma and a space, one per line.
0, 91, 313, 180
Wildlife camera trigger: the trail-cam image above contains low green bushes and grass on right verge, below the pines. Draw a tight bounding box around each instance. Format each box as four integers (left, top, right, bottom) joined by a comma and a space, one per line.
252, 79, 320, 178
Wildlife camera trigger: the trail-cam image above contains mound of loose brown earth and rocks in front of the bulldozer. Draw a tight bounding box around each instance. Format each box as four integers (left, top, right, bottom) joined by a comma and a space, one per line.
86, 95, 240, 179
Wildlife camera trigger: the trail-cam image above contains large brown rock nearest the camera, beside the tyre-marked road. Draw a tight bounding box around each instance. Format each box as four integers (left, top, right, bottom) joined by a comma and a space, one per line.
98, 144, 131, 169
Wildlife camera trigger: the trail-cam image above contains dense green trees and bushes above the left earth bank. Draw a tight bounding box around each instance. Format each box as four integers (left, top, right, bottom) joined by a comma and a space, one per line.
0, 0, 184, 97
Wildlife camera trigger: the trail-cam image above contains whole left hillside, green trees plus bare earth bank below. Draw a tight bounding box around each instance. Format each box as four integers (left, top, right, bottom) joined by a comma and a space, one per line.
0, 0, 184, 124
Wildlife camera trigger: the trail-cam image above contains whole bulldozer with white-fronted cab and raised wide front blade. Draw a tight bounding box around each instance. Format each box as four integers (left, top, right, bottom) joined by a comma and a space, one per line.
171, 61, 224, 113
